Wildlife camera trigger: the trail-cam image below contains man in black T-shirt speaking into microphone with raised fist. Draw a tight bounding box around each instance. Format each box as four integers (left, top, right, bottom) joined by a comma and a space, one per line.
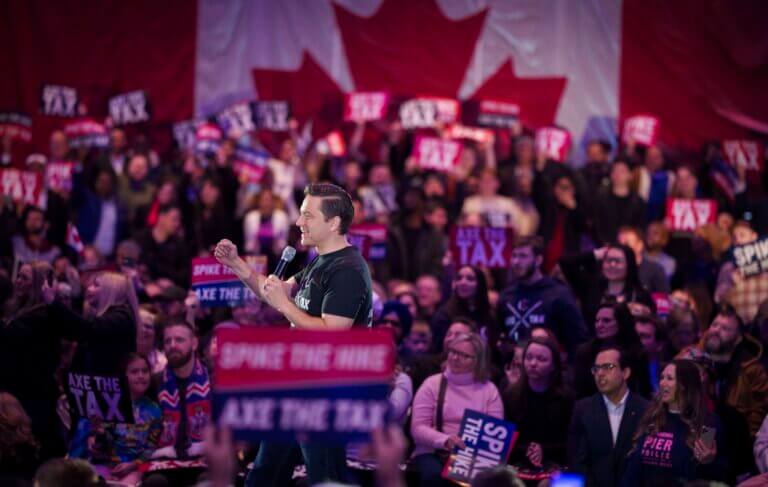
214, 184, 373, 486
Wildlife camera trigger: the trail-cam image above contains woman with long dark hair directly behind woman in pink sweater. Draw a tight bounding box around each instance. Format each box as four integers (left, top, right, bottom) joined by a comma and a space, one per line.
431, 265, 495, 346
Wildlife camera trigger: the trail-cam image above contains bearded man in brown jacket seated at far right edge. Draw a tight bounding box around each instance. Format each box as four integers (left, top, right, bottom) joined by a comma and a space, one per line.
697, 305, 768, 437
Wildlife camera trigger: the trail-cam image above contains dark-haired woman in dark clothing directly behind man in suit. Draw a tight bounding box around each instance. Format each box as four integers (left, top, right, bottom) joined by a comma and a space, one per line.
573, 299, 652, 399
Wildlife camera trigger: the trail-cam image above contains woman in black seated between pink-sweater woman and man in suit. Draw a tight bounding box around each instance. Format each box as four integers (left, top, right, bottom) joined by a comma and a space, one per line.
504, 336, 573, 469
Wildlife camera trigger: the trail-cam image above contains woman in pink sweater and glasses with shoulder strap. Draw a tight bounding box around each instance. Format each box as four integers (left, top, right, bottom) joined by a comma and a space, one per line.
411, 333, 504, 486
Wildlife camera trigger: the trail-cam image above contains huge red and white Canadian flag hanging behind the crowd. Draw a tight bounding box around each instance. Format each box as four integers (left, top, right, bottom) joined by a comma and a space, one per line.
0, 0, 768, 163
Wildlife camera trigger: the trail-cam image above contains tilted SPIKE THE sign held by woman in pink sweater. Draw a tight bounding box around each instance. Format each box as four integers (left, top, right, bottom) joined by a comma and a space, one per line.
443, 409, 517, 485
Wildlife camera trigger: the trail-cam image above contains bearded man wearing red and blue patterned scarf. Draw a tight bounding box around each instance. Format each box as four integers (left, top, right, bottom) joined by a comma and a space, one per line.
142, 322, 211, 487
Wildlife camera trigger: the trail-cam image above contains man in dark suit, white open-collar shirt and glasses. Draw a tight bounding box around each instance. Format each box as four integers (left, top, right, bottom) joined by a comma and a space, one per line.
568, 347, 648, 487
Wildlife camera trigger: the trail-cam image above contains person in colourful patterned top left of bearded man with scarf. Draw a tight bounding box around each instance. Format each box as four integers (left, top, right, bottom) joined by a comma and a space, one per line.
70, 353, 163, 485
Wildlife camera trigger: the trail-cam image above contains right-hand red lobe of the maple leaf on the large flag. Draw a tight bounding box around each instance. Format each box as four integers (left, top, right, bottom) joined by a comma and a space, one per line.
470, 59, 567, 127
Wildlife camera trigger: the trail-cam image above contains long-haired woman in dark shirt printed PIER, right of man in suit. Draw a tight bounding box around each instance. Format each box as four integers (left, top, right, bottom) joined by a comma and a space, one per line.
622, 360, 726, 487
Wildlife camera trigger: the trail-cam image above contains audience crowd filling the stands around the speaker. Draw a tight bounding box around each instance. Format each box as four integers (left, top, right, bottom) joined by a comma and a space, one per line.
0, 110, 768, 487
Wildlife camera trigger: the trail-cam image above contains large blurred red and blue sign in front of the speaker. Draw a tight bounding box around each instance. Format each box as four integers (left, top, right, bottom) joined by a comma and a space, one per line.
213, 328, 395, 442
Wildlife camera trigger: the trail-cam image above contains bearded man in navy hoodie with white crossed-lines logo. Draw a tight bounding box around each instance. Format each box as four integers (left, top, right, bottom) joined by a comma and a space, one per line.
497, 237, 587, 357
